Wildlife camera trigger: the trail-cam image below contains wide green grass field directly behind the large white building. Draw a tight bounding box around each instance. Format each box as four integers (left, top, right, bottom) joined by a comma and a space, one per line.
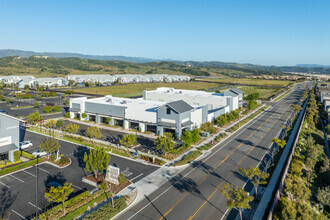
74, 82, 219, 97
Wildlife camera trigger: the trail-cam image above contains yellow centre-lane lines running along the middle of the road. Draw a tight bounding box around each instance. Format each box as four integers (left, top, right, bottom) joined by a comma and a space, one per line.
159, 102, 289, 220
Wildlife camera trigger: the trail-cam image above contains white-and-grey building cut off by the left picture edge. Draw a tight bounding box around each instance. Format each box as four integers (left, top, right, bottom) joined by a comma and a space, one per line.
0, 113, 23, 161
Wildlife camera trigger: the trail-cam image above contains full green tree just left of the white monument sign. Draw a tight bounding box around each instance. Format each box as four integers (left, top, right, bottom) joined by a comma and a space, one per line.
84, 147, 111, 179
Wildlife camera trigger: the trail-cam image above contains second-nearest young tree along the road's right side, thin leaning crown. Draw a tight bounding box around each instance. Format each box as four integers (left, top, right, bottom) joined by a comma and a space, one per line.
239, 167, 269, 197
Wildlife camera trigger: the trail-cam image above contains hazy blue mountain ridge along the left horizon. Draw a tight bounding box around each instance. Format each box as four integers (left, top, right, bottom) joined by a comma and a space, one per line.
0, 49, 170, 63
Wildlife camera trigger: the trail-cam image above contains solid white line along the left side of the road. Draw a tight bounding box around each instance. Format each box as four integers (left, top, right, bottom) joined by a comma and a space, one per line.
128, 100, 285, 220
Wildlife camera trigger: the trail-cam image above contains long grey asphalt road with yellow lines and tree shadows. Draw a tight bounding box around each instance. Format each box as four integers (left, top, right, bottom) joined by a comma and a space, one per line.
119, 83, 312, 220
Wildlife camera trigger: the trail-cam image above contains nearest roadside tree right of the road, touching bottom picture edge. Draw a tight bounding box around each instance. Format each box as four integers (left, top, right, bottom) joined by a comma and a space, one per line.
221, 184, 253, 220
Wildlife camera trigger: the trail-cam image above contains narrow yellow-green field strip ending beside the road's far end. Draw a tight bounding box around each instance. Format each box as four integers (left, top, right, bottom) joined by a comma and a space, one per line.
196, 78, 293, 87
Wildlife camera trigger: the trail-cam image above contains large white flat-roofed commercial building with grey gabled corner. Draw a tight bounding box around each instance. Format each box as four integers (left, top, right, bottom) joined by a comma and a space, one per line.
70, 88, 240, 138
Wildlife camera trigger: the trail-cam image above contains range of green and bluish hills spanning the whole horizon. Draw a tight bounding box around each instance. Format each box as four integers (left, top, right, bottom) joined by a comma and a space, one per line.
0, 49, 330, 77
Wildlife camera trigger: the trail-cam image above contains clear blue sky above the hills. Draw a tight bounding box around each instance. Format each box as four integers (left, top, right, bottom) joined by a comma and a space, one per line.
0, 0, 330, 65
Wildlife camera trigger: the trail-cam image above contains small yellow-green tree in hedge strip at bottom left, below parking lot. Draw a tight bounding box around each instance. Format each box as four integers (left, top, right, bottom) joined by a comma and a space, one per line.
45, 183, 73, 214
